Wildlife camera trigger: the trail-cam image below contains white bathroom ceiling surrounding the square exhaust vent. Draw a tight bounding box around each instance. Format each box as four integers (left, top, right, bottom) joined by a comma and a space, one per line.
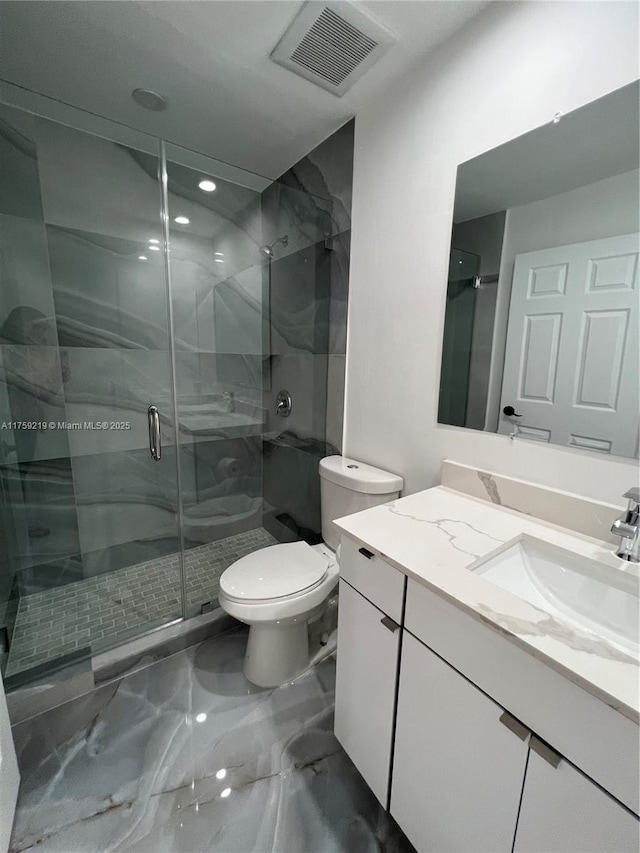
0, 0, 488, 178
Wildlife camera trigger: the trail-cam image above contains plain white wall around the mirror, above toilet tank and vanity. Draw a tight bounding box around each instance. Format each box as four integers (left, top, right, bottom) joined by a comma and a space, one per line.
344, 0, 638, 503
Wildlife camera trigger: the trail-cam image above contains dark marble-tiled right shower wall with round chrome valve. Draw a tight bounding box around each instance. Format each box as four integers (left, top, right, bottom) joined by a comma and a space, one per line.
262, 122, 354, 541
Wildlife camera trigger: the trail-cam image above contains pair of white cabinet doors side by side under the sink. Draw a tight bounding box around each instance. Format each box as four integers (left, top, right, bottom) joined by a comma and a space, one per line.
390, 631, 640, 853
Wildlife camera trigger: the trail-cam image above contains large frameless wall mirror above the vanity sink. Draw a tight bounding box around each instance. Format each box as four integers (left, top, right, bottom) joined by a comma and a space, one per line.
438, 82, 640, 457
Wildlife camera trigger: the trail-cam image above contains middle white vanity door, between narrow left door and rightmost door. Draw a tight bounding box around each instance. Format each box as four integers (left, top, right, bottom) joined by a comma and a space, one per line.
391, 631, 529, 853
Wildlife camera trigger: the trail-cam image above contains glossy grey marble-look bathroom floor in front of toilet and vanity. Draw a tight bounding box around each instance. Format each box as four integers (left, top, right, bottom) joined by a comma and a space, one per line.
10, 629, 415, 853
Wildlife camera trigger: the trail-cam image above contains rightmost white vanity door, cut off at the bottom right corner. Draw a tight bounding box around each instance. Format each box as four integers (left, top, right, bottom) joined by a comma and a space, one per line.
514, 740, 640, 853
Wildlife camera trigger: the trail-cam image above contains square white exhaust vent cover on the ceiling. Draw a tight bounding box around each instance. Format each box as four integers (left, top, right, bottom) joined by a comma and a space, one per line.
271, 0, 396, 97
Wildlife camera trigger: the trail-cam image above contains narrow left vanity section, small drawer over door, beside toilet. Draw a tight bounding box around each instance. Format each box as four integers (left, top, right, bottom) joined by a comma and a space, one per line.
335, 540, 405, 808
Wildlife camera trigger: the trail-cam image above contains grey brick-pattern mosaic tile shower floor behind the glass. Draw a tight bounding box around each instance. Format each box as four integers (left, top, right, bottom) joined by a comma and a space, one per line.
5, 528, 277, 677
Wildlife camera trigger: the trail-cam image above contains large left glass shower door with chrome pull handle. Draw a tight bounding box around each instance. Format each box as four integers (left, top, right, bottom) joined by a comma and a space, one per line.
0, 101, 182, 684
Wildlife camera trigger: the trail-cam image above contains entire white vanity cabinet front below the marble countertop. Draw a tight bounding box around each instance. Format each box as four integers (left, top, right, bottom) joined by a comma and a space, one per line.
335, 537, 640, 853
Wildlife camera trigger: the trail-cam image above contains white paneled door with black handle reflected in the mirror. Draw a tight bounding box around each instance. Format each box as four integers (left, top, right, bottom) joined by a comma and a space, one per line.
500, 234, 640, 456
